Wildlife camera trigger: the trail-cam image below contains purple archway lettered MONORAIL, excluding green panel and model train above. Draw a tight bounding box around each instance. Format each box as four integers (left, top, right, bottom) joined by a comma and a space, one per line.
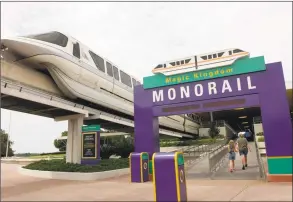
134, 59, 292, 181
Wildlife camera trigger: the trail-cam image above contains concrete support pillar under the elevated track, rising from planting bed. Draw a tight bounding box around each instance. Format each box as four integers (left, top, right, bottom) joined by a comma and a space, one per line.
66, 116, 83, 164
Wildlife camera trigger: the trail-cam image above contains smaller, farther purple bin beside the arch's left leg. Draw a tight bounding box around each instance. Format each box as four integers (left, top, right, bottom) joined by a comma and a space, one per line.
129, 152, 149, 183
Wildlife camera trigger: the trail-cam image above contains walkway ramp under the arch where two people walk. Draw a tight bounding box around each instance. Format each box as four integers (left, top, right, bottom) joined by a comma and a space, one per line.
213, 142, 260, 180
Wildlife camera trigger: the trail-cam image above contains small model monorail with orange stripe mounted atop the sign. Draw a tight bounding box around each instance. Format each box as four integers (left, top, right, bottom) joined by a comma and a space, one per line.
152, 48, 249, 76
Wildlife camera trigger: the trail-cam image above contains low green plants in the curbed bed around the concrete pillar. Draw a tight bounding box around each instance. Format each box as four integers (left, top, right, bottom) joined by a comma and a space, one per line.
24, 158, 129, 173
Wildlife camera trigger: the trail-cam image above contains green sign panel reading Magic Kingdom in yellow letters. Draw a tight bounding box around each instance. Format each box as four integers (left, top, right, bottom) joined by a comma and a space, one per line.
143, 56, 266, 89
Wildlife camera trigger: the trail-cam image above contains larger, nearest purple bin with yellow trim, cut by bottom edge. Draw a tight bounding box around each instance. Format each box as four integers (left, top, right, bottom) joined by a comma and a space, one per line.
152, 152, 187, 202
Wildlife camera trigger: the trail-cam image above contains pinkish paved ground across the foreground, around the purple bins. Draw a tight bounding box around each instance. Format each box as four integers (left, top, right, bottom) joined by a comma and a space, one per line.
1, 164, 292, 201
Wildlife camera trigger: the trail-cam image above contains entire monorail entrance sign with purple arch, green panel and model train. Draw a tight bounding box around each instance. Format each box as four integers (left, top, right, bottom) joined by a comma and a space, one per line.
134, 49, 292, 181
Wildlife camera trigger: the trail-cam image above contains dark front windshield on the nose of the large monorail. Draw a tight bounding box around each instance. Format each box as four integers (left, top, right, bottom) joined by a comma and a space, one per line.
24, 32, 68, 47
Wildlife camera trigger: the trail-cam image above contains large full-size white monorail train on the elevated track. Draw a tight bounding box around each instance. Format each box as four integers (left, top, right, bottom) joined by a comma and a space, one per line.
1, 32, 199, 134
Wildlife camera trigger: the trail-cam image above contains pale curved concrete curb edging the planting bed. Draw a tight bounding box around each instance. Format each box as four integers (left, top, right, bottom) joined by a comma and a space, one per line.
18, 167, 129, 181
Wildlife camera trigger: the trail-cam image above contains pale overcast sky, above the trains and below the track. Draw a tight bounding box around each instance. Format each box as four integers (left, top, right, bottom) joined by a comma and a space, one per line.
1, 2, 292, 153
